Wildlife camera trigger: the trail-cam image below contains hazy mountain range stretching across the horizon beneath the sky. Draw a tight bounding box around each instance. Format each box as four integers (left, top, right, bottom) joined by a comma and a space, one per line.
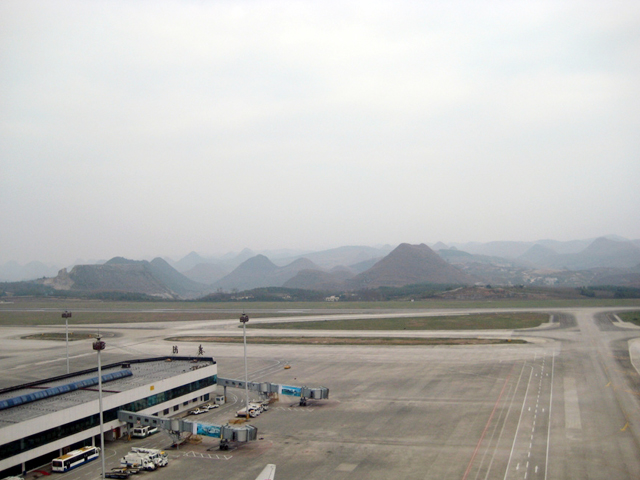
5, 237, 640, 298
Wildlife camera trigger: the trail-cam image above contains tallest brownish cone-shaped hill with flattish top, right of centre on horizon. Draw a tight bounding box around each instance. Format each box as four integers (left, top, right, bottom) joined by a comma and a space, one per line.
349, 243, 474, 289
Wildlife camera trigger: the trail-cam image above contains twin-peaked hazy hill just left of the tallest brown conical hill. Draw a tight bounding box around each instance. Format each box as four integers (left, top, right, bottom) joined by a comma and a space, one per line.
213, 255, 318, 291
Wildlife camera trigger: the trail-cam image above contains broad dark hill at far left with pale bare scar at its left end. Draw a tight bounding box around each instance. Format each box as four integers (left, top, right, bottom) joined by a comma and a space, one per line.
42, 257, 206, 298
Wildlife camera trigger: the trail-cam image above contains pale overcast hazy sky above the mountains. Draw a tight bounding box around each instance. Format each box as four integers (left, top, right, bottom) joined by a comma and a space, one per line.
0, 0, 640, 263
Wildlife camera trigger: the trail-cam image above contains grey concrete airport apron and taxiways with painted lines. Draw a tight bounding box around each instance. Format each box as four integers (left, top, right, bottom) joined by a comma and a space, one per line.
0, 308, 640, 480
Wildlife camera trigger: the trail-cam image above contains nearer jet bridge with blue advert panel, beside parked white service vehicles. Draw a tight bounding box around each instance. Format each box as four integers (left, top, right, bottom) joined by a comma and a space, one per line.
118, 410, 258, 450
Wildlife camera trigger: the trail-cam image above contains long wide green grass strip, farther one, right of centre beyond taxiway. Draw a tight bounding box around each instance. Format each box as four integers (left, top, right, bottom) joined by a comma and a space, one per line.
247, 313, 549, 330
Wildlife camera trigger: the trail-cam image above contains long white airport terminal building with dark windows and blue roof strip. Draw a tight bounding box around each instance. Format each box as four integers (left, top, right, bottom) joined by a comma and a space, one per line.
0, 356, 218, 478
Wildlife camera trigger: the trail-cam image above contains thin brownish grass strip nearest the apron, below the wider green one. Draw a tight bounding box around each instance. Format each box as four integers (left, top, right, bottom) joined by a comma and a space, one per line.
165, 336, 527, 346
